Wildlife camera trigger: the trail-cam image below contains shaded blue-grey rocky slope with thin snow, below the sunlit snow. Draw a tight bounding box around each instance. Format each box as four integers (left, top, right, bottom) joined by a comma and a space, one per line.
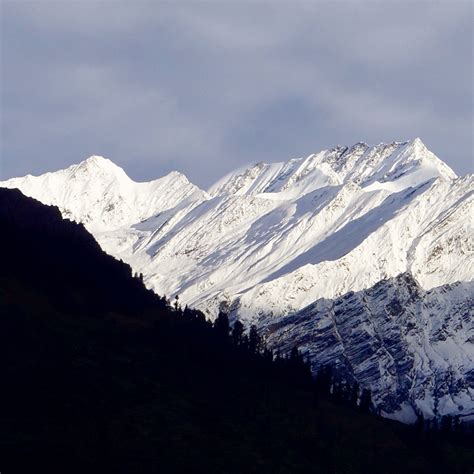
259, 273, 474, 422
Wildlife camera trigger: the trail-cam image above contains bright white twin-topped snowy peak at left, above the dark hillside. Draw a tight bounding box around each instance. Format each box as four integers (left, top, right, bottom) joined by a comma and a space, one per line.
0, 155, 207, 233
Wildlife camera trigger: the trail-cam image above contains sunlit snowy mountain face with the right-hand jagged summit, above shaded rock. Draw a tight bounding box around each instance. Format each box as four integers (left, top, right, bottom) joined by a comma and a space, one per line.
97, 140, 473, 318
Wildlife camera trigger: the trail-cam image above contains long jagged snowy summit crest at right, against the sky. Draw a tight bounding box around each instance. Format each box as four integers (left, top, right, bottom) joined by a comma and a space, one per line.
209, 138, 456, 199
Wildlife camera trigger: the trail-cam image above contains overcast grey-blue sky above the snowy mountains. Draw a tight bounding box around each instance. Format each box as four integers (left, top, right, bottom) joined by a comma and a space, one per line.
0, 0, 474, 187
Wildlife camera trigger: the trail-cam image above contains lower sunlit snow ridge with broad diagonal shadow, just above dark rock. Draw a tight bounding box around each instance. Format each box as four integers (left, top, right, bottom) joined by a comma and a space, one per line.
230, 176, 474, 324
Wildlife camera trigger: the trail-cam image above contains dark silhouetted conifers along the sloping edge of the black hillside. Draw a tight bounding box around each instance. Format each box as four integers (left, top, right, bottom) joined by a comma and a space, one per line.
161, 296, 474, 441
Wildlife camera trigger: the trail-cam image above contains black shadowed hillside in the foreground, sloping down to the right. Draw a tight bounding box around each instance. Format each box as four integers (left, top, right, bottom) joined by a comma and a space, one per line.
0, 189, 474, 474
